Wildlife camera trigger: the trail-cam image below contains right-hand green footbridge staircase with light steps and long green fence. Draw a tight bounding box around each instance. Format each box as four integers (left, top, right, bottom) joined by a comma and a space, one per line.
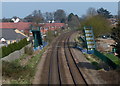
81, 27, 119, 69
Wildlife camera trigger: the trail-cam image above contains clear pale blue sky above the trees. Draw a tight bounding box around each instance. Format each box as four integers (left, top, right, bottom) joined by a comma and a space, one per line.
2, 2, 118, 18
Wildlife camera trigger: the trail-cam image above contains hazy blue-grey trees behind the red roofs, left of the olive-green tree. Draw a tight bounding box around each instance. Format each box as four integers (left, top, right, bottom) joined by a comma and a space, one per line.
2, 9, 80, 27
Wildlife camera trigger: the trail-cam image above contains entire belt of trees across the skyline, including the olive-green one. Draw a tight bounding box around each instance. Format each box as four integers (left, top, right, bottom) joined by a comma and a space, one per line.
2, 7, 120, 57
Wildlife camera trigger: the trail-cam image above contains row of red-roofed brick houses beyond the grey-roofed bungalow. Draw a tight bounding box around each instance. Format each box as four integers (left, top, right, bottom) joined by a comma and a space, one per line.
0, 22, 65, 36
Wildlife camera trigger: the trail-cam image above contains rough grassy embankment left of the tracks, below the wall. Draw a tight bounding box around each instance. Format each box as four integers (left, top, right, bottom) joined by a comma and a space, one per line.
2, 48, 46, 84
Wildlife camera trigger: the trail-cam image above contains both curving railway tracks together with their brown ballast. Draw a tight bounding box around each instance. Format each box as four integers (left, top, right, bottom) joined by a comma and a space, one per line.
41, 31, 87, 86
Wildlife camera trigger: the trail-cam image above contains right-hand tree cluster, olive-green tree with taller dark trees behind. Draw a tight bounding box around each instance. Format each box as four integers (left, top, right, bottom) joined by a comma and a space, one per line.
81, 8, 120, 58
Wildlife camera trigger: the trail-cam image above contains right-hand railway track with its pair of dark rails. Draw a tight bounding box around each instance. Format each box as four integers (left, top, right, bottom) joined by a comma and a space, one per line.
64, 31, 88, 86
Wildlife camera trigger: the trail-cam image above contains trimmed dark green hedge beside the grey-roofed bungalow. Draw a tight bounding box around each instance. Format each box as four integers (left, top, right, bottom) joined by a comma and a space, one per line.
1, 38, 29, 58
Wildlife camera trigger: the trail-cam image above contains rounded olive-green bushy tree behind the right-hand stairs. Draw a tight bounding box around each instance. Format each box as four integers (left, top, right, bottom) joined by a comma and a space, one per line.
81, 15, 111, 38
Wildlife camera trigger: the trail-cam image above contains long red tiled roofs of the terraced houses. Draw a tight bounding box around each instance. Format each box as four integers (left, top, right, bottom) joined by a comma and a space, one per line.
0, 22, 64, 30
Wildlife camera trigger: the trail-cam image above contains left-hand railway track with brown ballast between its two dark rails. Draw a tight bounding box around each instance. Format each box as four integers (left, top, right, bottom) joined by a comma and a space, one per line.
48, 35, 63, 84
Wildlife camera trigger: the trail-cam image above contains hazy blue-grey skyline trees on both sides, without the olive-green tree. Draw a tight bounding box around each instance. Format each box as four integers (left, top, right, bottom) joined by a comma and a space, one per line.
2, 8, 112, 27
